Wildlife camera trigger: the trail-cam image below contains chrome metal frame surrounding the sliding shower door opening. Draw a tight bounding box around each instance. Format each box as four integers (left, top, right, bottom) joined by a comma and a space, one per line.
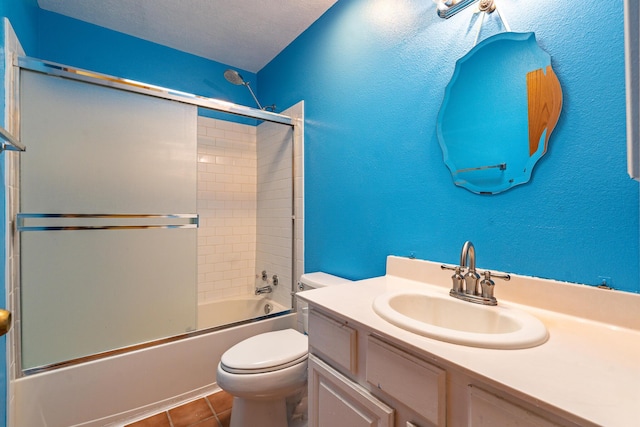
10, 56, 302, 378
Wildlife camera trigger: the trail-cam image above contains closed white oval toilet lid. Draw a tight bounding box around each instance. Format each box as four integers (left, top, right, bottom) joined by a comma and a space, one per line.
220, 329, 309, 373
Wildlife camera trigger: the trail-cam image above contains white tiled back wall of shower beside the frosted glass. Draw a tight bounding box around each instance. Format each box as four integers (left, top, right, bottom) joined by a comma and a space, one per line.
198, 117, 257, 302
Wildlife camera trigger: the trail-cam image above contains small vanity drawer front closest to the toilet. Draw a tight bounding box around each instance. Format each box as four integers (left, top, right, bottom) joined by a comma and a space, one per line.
309, 310, 358, 374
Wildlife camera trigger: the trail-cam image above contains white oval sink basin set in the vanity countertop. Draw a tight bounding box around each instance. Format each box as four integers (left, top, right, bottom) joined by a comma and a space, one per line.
373, 291, 548, 349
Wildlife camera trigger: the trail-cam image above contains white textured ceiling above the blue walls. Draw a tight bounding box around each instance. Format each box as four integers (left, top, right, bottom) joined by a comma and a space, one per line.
38, 0, 337, 72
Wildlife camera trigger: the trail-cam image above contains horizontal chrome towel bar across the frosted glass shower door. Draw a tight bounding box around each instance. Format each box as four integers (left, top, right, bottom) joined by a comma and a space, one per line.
16, 213, 198, 231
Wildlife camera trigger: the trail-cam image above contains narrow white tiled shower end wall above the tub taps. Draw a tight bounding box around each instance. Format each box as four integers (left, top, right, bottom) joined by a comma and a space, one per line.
256, 103, 303, 307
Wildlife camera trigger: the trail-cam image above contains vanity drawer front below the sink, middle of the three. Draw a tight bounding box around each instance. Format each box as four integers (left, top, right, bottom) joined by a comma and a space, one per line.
366, 336, 447, 426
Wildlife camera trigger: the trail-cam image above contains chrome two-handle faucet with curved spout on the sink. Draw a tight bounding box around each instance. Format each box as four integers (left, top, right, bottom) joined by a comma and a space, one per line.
440, 241, 511, 305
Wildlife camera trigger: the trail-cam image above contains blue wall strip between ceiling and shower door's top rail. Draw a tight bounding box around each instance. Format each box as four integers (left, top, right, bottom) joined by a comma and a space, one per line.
35, 10, 258, 123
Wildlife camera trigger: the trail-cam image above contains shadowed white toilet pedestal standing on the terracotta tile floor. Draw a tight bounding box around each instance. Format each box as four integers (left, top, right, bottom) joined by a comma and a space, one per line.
230, 397, 288, 427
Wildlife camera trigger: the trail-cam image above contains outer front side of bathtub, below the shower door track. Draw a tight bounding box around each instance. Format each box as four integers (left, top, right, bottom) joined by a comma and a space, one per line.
8, 310, 296, 427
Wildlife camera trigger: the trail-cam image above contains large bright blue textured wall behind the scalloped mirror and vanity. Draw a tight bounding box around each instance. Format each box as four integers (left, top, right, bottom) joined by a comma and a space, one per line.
258, 0, 640, 292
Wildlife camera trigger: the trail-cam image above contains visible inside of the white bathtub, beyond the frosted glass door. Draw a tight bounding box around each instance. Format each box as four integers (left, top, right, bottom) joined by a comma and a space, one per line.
197, 295, 288, 329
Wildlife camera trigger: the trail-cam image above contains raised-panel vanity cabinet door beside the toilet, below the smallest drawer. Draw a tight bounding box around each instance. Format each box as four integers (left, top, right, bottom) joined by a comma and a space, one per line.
309, 355, 394, 427
